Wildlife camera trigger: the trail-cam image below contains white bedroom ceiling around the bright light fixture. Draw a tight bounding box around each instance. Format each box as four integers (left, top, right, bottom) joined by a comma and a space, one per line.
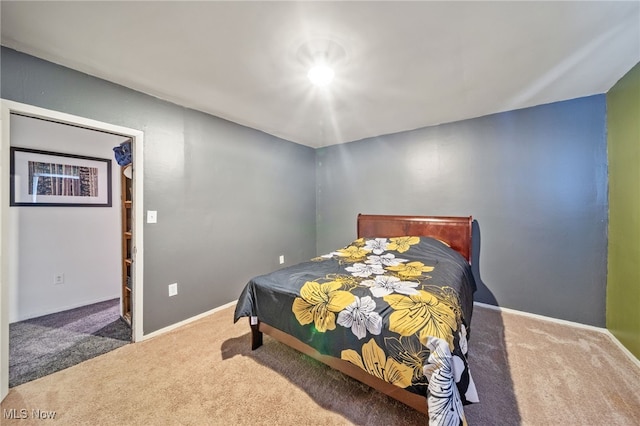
1, 0, 640, 147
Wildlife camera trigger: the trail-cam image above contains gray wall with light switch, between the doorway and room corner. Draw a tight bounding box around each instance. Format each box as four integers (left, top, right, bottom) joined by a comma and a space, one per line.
0, 47, 316, 333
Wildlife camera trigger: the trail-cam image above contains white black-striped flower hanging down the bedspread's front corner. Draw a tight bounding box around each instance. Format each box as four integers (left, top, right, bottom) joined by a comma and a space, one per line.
424, 337, 467, 426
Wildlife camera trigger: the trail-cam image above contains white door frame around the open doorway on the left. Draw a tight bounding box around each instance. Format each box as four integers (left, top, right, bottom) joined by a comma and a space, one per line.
0, 99, 144, 401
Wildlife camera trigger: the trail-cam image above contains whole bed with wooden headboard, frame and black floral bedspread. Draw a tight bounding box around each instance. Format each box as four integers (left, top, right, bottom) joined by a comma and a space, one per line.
234, 214, 478, 424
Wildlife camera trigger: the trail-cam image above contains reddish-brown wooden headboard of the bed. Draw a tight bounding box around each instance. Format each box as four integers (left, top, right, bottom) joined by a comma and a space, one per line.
358, 214, 473, 262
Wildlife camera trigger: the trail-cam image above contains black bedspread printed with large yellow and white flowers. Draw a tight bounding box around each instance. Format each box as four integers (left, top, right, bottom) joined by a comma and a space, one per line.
237, 236, 477, 425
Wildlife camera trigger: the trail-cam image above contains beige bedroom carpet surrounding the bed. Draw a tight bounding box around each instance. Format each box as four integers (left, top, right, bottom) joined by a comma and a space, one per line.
1, 307, 640, 425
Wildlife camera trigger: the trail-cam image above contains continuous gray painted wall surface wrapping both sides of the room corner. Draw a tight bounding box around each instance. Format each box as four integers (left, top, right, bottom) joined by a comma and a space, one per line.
1, 48, 608, 333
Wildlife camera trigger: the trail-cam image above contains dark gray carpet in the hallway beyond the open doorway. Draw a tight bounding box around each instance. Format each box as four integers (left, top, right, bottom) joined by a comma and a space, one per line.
9, 299, 131, 387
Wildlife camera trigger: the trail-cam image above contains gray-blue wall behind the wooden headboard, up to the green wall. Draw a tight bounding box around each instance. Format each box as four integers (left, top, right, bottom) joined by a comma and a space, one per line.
316, 95, 608, 327
